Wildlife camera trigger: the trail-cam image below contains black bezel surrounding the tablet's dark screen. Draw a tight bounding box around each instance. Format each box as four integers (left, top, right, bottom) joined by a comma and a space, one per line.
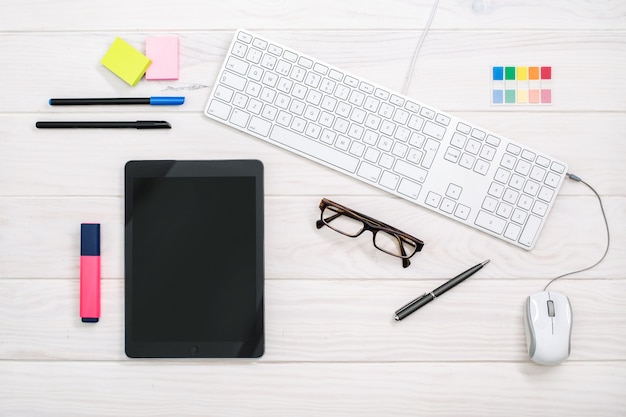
124, 160, 265, 358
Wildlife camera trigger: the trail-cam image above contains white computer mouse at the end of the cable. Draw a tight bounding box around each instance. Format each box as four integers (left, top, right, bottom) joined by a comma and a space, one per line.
524, 291, 572, 365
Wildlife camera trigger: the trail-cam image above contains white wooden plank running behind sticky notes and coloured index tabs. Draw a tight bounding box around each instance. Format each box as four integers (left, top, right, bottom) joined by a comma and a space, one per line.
0, 31, 626, 112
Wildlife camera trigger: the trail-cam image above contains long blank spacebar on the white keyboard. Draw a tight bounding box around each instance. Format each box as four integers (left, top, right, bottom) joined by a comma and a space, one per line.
270, 125, 359, 173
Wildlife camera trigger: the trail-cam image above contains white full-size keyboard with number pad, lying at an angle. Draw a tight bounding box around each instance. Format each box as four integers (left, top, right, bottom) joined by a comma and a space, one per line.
205, 30, 567, 250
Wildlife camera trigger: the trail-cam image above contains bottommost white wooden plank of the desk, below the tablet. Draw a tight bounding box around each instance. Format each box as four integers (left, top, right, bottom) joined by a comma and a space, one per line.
0, 361, 626, 417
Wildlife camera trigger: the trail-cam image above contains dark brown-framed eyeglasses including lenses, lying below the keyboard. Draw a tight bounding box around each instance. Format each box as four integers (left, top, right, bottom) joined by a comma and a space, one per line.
316, 198, 424, 268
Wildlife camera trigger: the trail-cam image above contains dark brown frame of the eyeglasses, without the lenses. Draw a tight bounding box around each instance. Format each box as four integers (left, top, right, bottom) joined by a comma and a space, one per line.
315, 198, 424, 268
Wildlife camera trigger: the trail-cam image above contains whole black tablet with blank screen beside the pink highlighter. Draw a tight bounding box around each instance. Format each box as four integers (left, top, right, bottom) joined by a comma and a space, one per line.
125, 160, 264, 358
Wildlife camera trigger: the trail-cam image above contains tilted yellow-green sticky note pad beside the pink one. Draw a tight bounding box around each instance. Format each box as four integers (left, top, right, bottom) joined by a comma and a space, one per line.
100, 37, 152, 86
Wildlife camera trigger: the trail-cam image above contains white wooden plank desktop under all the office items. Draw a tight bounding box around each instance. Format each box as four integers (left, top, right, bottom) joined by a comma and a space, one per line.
0, 0, 626, 417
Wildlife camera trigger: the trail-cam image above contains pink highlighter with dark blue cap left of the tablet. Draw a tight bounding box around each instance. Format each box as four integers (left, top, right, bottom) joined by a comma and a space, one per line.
80, 223, 100, 323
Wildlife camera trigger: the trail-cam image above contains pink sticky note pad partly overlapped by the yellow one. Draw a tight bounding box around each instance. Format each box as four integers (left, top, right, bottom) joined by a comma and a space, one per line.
146, 36, 178, 80
